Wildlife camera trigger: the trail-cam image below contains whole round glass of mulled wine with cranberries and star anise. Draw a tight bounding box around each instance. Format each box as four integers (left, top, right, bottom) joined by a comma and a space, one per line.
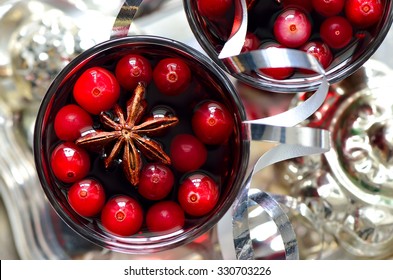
35, 36, 248, 253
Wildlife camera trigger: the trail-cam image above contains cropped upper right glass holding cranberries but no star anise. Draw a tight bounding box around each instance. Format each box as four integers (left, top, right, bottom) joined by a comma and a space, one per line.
183, 0, 393, 92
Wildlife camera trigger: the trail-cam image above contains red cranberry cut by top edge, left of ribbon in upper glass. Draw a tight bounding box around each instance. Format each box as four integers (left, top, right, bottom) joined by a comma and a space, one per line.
197, 0, 233, 20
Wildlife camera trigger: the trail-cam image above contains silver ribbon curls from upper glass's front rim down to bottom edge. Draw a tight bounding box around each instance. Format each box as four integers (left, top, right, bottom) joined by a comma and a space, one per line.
218, 59, 330, 260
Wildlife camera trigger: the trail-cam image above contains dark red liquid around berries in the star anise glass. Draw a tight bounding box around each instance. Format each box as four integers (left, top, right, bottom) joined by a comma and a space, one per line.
42, 42, 242, 236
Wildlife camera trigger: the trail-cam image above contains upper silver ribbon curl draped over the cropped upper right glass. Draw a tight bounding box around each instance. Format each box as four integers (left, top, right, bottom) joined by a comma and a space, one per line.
218, 0, 329, 126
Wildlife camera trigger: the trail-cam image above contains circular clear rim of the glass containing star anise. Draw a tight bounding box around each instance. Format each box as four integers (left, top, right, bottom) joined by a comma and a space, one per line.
33, 35, 250, 254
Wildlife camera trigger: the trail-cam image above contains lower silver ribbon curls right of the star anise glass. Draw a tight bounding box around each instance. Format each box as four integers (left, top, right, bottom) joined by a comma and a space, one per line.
218, 123, 330, 260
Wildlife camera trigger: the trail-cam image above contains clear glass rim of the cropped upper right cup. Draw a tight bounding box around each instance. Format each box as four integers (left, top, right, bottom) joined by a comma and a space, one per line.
183, 0, 393, 93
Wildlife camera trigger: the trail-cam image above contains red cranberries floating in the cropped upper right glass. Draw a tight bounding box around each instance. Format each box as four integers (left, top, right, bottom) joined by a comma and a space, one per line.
197, 0, 384, 79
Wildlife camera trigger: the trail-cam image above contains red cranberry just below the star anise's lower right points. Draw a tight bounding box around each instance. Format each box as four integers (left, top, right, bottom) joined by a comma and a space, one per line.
138, 163, 175, 200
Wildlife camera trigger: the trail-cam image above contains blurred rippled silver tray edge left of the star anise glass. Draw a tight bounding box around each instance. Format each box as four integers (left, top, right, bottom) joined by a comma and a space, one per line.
0, 97, 92, 259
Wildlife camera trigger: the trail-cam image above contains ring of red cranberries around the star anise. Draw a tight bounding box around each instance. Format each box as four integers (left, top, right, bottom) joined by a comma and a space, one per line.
50, 53, 234, 236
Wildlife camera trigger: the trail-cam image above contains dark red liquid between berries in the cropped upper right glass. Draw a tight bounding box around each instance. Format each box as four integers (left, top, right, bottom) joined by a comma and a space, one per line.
190, 0, 388, 77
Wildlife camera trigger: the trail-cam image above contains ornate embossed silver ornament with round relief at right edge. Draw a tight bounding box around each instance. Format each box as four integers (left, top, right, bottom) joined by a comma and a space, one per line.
277, 61, 393, 258
